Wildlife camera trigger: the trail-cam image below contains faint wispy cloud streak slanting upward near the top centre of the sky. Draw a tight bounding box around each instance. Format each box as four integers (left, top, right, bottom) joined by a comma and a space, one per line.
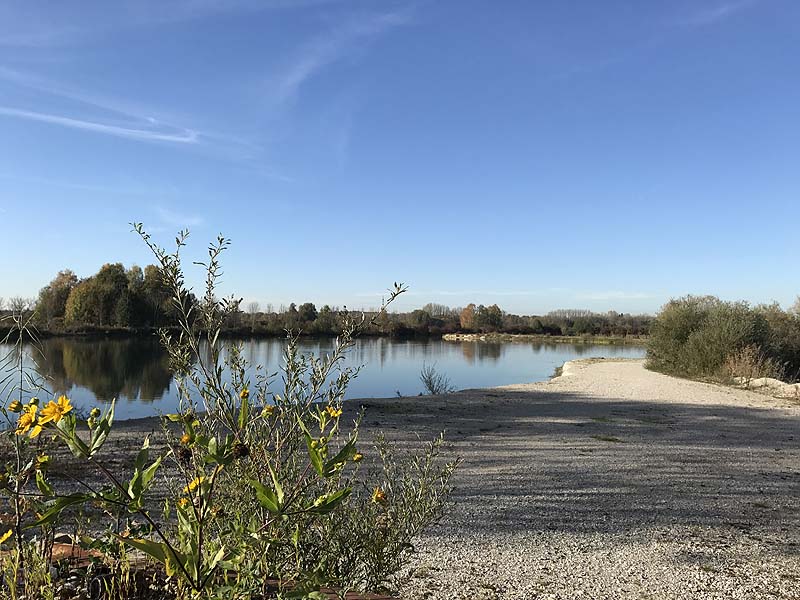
271, 11, 411, 104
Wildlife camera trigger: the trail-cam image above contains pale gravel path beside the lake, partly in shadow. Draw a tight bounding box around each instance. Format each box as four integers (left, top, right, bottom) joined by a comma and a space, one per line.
363, 361, 800, 600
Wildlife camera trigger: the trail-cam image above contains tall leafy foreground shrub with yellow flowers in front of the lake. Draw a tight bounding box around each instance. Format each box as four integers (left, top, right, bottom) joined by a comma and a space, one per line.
0, 225, 455, 599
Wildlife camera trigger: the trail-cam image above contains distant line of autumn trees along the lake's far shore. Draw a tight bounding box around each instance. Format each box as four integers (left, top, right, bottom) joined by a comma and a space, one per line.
0, 263, 652, 337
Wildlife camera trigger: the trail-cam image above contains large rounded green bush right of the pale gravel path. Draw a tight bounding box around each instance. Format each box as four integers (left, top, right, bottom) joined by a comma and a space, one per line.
647, 296, 800, 377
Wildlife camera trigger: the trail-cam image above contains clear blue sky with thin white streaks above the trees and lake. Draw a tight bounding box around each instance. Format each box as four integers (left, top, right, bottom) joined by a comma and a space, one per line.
0, 0, 800, 313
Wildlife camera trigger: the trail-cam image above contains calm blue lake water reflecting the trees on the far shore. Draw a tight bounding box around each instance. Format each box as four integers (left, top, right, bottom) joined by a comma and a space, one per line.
0, 338, 644, 419
